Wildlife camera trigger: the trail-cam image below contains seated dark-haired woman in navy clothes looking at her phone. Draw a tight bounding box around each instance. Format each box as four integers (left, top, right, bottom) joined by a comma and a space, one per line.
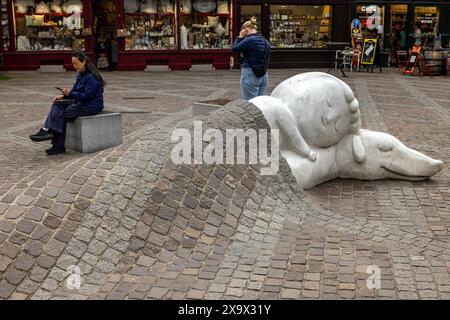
30, 51, 105, 155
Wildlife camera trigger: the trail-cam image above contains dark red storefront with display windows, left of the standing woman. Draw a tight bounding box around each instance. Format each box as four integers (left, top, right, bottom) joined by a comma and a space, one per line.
0, 0, 236, 70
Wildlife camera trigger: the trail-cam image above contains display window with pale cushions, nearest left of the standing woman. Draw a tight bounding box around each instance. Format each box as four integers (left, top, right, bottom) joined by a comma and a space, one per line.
179, 0, 232, 50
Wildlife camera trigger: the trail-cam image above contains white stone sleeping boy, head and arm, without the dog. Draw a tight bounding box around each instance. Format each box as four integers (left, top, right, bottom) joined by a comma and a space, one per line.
250, 72, 365, 162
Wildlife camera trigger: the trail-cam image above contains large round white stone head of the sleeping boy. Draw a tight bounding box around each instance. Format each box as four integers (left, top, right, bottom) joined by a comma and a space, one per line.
272, 72, 361, 147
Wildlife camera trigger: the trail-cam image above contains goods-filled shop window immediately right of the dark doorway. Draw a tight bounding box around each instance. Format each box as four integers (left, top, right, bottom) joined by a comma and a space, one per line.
124, 0, 177, 50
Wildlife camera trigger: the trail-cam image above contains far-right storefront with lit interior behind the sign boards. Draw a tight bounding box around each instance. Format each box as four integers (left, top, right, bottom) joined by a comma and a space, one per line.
352, 0, 450, 51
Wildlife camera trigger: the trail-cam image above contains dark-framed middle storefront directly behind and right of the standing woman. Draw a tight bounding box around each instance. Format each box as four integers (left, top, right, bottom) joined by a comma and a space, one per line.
238, 0, 351, 68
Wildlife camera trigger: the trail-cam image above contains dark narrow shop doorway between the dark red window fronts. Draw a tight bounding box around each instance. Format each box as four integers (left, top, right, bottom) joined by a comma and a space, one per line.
93, 0, 118, 71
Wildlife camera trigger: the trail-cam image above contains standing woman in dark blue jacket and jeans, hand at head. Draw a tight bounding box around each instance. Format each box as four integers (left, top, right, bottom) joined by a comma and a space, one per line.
233, 17, 271, 100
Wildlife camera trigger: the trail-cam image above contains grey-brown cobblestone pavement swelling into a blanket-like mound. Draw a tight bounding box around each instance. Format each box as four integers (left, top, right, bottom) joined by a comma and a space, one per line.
0, 70, 450, 299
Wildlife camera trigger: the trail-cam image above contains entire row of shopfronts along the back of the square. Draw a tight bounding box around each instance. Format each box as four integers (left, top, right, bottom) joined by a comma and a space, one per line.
0, 0, 450, 70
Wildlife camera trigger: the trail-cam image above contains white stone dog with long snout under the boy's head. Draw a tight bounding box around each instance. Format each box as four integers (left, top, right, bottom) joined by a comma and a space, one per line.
285, 129, 443, 189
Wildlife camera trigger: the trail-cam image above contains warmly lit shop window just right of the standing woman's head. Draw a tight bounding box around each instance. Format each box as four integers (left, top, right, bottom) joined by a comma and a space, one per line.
270, 5, 331, 48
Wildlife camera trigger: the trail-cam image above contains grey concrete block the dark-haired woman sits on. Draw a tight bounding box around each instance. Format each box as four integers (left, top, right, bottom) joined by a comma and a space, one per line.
66, 112, 122, 153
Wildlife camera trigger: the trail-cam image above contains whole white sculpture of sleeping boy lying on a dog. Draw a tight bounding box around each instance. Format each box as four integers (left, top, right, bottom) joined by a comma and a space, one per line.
250, 72, 442, 189
